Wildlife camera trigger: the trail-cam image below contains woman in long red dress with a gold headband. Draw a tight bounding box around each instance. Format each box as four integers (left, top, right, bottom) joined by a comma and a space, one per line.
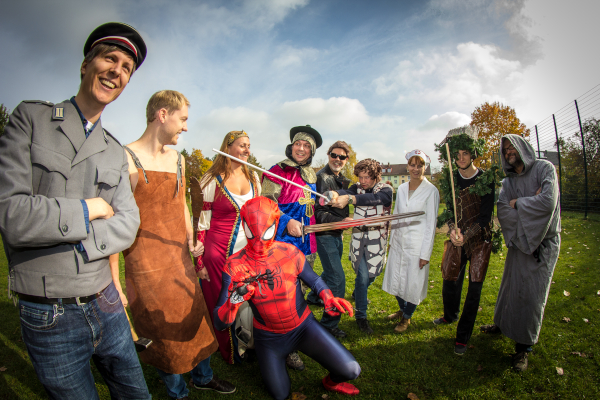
196, 131, 260, 364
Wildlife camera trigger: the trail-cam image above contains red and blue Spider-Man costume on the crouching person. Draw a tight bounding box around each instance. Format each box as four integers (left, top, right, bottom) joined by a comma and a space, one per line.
213, 197, 360, 399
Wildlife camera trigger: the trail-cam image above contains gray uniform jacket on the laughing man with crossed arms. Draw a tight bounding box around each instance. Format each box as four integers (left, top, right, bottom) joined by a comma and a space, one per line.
0, 100, 140, 298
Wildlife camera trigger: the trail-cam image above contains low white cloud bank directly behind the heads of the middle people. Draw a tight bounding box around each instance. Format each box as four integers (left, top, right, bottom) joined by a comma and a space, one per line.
189, 97, 412, 166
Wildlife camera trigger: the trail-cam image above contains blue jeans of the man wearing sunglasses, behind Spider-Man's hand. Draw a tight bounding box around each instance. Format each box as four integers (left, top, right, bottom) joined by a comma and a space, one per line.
309, 235, 346, 329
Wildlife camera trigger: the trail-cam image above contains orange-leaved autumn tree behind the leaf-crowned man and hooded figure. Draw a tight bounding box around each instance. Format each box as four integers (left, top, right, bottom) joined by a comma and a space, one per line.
471, 102, 530, 169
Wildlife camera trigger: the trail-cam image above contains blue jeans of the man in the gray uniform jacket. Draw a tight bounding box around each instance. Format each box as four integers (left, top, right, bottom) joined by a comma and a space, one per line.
19, 282, 151, 400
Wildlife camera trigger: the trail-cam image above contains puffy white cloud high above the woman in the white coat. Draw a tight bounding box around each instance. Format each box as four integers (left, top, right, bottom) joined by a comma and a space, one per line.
373, 42, 523, 110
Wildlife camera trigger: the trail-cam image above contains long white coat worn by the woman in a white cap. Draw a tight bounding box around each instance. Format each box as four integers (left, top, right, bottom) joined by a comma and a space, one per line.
382, 178, 440, 304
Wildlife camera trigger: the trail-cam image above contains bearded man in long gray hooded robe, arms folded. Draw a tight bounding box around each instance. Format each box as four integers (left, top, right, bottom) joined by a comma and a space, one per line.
481, 135, 561, 371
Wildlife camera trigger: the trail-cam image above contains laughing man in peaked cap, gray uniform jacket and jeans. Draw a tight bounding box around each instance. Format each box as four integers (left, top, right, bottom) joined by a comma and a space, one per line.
0, 22, 150, 400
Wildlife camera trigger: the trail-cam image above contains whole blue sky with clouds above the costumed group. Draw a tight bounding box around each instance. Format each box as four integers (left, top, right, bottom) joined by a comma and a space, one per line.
0, 0, 600, 166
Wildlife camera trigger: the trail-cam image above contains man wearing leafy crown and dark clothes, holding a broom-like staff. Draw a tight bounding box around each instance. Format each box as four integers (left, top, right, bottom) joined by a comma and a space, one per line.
433, 125, 501, 355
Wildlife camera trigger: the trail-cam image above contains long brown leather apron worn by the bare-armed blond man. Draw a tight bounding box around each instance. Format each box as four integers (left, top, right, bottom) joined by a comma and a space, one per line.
123, 152, 217, 374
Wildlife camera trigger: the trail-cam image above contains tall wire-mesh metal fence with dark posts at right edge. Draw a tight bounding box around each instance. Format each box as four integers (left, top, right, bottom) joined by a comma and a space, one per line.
529, 85, 600, 217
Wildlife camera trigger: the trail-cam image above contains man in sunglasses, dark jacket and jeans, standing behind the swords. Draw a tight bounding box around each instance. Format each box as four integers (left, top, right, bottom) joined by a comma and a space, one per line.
306, 140, 352, 338
